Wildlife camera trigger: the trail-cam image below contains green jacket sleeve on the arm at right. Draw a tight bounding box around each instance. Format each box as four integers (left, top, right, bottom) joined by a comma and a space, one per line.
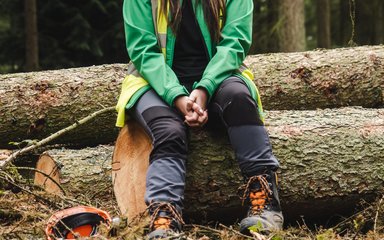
195, 0, 253, 96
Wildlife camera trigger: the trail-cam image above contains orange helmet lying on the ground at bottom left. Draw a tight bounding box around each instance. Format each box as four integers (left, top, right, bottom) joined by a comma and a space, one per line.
45, 206, 112, 240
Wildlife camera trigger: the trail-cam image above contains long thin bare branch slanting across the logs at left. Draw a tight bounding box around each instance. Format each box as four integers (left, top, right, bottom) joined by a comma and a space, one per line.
0, 107, 115, 169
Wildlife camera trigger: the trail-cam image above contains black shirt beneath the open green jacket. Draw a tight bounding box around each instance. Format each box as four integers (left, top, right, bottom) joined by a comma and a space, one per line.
172, 0, 208, 91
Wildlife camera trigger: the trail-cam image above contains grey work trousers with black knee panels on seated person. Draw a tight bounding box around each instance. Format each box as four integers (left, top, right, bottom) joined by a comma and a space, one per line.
130, 77, 279, 210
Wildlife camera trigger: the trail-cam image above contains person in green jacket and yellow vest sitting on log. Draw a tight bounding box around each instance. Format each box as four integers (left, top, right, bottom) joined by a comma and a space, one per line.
116, 0, 283, 239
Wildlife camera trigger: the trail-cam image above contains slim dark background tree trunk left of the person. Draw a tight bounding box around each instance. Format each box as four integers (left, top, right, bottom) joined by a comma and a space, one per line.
24, 0, 39, 72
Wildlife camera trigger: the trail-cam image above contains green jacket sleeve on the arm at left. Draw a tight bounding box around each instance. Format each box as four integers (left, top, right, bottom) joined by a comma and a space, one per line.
123, 0, 188, 106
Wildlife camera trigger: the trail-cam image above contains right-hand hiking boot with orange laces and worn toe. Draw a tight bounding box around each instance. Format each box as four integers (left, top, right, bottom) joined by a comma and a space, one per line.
240, 171, 284, 235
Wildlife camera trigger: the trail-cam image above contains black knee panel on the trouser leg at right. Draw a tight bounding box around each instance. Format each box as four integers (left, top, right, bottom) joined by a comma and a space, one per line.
214, 77, 263, 126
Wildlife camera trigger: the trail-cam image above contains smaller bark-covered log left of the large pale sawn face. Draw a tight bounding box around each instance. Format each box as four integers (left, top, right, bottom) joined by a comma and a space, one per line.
37, 145, 113, 204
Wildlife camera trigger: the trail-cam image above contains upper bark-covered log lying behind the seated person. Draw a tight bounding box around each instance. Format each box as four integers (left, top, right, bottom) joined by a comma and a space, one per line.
0, 46, 384, 147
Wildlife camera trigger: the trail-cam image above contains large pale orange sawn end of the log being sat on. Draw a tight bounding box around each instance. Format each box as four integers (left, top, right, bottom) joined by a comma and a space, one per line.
112, 121, 152, 219
